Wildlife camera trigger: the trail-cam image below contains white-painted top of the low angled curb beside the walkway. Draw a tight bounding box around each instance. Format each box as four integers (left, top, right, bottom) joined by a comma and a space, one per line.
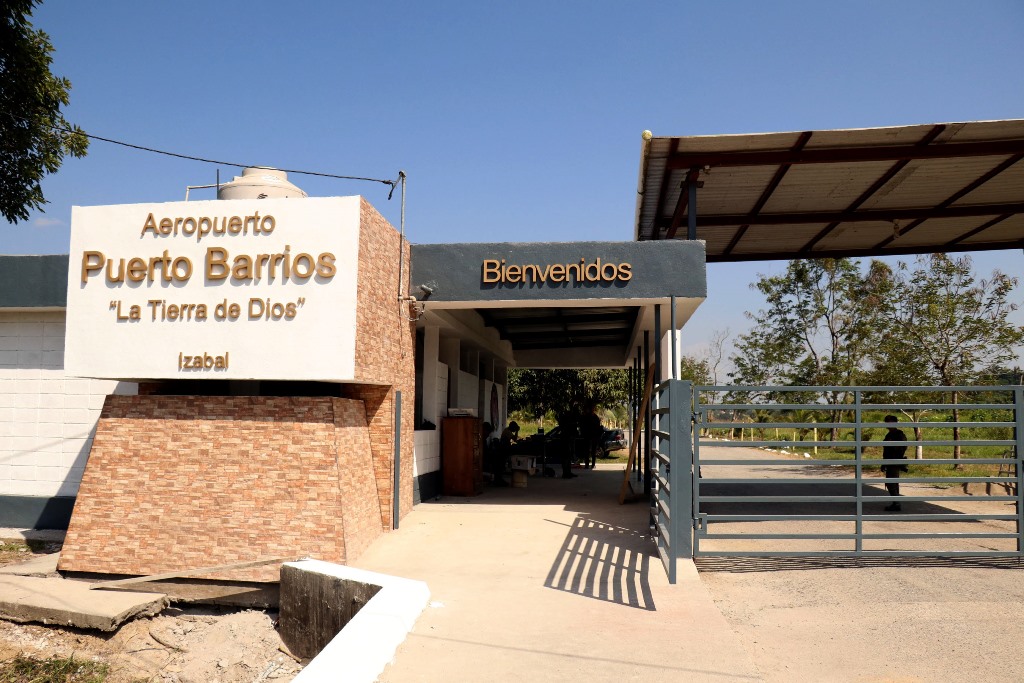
287, 560, 430, 683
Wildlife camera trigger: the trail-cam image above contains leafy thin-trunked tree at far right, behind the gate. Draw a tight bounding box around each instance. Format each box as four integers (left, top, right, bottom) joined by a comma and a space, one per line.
872, 254, 1024, 458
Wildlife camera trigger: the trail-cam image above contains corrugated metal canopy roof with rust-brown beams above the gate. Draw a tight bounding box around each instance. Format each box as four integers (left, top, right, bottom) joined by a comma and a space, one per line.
635, 120, 1024, 262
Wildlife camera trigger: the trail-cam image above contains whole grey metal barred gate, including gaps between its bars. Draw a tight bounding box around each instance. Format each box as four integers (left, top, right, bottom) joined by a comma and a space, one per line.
651, 380, 1024, 582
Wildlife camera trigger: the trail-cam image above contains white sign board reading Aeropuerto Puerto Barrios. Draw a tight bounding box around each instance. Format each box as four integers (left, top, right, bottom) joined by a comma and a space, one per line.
65, 197, 359, 381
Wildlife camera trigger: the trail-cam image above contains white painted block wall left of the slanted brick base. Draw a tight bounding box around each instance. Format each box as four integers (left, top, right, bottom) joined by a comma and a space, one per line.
0, 311, 137, 497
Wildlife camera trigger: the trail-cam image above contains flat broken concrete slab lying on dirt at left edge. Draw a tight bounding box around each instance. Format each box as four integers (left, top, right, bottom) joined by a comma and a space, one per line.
0, 574, 168, 631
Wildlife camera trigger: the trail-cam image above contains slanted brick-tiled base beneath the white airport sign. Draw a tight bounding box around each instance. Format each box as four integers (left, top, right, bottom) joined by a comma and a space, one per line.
58, 396, 382, 582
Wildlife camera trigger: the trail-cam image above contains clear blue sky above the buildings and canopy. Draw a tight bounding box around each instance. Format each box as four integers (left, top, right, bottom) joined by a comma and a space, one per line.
0, 0, 1024, 366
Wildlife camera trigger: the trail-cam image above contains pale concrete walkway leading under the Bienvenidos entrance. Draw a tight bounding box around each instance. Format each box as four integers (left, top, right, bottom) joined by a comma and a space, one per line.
353, 465, 762, 683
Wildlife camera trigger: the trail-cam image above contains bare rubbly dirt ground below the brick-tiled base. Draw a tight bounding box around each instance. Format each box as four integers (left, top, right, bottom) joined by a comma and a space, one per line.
0, 542, 302, 683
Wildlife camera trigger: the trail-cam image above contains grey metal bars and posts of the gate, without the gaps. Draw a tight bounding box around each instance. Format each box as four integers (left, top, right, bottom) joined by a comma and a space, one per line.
650, 380, 1024, 583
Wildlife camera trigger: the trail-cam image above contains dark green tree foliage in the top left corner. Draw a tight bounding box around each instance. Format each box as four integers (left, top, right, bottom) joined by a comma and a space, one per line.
0, 0, 89, 223
